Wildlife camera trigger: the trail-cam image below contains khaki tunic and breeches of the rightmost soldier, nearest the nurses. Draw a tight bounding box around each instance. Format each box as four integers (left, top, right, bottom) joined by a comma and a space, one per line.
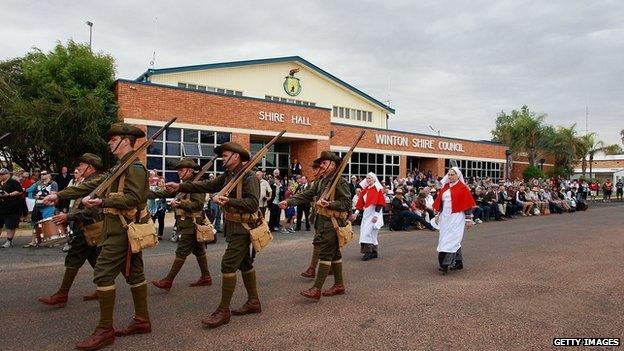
287, 177, 351, 261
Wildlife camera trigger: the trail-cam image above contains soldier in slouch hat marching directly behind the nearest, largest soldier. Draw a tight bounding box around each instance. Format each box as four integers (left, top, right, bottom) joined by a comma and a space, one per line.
166, 142, 262, 328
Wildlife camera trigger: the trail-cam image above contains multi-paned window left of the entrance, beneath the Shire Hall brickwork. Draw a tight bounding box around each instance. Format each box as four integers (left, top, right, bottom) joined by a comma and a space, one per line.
147, 126, 231, 181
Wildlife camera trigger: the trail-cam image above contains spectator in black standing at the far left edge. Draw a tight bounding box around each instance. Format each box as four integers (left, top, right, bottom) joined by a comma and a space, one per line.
0, 168, 24, 249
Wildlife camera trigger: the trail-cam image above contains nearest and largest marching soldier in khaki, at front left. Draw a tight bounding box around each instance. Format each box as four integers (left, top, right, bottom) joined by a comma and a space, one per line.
44, 123, 152, 350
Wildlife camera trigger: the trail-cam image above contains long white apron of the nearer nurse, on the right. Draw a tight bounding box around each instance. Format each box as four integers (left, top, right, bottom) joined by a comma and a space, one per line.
438, 188, 466, 252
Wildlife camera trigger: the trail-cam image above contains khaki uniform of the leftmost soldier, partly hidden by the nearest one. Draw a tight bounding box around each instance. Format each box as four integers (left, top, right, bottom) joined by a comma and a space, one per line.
65, 173, 104, 269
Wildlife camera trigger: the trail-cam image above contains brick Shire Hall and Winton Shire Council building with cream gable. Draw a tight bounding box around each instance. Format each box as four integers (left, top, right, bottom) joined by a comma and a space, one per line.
115, 56, 540, 183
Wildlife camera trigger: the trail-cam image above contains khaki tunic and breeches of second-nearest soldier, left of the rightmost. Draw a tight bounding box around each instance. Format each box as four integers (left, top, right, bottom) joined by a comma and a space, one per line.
179, 165, 260, 273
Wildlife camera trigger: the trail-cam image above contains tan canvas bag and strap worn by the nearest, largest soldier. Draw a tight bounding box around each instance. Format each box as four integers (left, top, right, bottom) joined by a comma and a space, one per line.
103, 174, 158, 254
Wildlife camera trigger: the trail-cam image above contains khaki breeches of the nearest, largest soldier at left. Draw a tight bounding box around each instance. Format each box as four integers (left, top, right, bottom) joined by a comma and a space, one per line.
93, 230, 145, 287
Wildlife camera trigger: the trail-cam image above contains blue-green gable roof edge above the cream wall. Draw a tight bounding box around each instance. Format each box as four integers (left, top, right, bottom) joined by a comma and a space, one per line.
135, 56, 394, 113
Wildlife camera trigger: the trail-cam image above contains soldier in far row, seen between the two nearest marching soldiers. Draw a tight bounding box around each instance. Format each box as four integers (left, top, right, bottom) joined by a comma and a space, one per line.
149, 159, 212, 291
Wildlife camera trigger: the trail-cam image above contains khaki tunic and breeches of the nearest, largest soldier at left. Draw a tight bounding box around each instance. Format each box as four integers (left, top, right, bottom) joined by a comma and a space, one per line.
57, 153, 149, 287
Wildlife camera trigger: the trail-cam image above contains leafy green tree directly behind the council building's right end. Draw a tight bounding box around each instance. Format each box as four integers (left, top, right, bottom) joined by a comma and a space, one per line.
491, 105, 551, 166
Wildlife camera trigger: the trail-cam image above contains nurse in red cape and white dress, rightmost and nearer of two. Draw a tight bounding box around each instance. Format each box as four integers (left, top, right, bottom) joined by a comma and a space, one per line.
432, 167, 476, 274
